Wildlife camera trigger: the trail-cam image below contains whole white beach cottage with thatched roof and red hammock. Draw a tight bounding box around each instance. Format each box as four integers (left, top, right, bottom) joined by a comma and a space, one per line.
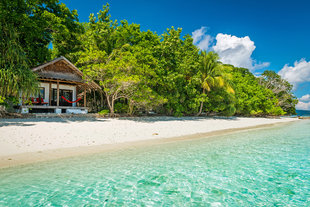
20, 57, 100, 114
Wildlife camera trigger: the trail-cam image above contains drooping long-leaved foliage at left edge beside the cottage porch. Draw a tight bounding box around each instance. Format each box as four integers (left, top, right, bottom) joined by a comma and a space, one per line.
0, 23, 38, 102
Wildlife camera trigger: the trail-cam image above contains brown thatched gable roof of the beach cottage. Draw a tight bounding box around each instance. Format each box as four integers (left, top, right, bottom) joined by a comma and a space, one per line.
32, 56, 100, 89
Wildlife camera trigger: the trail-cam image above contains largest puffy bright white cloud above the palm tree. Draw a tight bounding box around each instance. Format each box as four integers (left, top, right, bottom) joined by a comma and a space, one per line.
213, 33, 269, 70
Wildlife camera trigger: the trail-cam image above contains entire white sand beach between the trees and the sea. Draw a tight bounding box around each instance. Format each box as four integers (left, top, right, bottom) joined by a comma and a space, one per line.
0, 117, 298, 167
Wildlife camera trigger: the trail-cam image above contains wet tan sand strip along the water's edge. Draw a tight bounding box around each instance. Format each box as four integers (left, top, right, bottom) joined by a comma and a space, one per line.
0, 118, 299, 169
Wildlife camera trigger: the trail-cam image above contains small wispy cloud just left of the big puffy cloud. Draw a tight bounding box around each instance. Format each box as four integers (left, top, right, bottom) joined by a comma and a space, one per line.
192, 27, 213, 50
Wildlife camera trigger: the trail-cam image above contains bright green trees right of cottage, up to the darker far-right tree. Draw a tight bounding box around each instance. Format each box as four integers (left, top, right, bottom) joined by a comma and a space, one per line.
70, 4, 294, 116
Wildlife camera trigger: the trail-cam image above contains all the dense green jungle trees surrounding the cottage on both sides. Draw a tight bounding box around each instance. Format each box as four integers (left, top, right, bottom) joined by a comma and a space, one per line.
0, 0, 297, 116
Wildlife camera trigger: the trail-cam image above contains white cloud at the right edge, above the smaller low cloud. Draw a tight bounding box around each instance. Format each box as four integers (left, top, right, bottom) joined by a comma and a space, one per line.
279, 59, 310, 88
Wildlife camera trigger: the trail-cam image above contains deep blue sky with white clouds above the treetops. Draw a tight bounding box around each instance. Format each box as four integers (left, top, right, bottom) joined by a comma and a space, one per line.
60, 0, 310, 109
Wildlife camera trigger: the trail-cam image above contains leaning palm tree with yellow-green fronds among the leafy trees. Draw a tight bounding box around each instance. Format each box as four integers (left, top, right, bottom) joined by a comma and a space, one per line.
197, 51, 234, 116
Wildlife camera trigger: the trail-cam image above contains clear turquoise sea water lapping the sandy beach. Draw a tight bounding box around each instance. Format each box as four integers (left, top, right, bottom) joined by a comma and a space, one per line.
0, 121, 310, 206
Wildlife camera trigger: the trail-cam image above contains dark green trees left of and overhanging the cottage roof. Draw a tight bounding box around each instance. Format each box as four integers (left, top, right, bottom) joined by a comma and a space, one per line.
0, 0, 82, 111
